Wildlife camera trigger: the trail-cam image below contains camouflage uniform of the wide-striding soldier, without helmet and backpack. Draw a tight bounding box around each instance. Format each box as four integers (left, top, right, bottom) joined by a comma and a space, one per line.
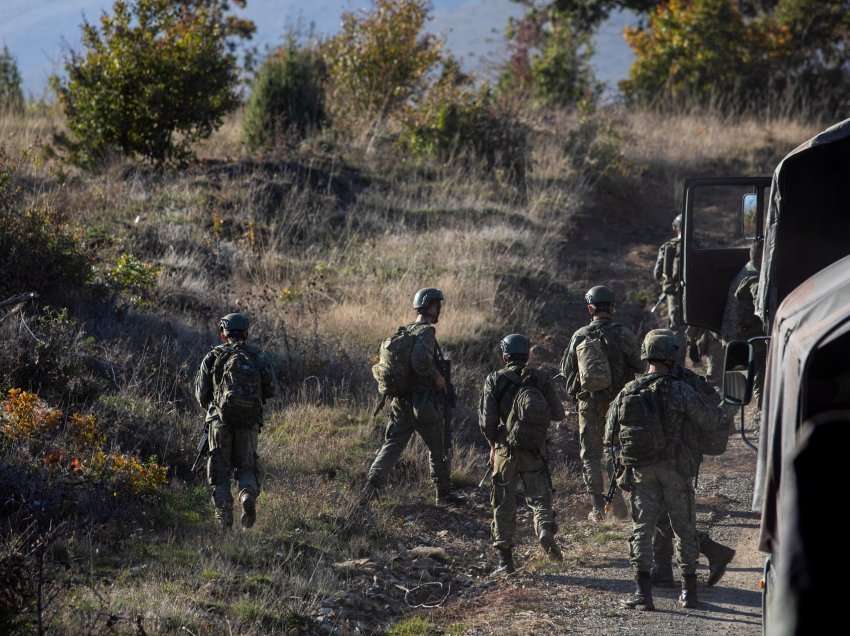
368, 323, 451, 496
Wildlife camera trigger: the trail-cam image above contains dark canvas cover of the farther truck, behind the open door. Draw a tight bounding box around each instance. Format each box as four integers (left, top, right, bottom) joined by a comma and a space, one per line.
756, 119, 850, 327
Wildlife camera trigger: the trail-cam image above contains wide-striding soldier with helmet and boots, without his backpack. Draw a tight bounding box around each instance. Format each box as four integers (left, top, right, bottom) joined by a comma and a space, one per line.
363, 287, 462, 505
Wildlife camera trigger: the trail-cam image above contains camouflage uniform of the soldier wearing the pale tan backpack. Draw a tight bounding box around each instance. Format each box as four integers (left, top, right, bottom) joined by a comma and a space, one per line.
561, 318, 644, 497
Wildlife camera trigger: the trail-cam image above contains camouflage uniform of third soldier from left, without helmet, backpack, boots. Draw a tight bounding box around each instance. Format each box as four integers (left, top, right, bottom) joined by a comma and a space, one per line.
479, 362, 565, 549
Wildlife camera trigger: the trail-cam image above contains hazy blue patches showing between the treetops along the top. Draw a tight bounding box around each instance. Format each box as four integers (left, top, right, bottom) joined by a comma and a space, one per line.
0, 0, 632, 97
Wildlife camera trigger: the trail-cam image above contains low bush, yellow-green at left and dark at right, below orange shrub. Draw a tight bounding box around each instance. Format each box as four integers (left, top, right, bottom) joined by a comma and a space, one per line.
401, 67, 529, 181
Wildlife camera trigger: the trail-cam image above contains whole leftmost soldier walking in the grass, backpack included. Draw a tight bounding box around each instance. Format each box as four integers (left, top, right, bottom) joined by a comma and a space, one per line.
195, 313, 274, 530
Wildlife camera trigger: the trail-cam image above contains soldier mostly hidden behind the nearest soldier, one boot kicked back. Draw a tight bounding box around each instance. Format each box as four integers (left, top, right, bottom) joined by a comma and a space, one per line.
651, 329, 735, 587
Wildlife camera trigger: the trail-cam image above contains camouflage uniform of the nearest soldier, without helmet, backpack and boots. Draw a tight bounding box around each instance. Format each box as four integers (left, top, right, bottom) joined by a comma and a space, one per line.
605, 376, 717, 577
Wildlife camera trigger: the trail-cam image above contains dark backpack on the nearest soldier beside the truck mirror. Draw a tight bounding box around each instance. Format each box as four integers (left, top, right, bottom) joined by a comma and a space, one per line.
618, 376, 668, 466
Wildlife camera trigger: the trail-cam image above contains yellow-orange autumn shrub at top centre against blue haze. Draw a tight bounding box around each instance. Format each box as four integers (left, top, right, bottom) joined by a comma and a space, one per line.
322, 0, 441, 124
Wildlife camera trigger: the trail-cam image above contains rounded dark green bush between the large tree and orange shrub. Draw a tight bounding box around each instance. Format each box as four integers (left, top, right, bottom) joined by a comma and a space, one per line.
242, 40, 325, 150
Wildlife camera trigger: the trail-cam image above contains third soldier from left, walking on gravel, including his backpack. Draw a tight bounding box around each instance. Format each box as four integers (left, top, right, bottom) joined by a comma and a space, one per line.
479, 334, 565, 574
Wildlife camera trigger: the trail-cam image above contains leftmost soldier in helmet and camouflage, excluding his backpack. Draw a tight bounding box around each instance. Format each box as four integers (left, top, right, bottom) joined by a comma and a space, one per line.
195, 313, 275, 529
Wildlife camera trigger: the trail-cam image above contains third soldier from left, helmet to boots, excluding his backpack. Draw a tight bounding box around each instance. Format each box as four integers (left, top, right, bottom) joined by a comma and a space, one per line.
479, 334, 565, 574
